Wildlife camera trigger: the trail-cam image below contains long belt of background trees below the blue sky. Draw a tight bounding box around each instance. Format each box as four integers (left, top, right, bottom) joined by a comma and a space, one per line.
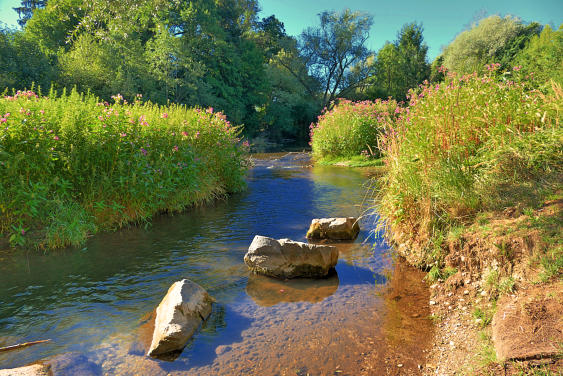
0, 0, 563, 144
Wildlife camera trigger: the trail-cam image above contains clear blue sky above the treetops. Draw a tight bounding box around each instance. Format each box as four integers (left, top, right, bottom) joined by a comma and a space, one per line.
0, 0, 563, 60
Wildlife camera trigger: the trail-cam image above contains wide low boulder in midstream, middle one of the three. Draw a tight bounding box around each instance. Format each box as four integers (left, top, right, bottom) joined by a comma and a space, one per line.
244, 235, 338, 278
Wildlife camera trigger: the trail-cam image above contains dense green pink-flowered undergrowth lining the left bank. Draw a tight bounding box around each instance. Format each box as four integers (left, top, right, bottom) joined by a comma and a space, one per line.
0, 86, 247, 248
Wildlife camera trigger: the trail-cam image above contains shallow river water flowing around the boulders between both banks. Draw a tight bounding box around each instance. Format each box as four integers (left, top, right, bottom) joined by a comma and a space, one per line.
0, 153, 432, 375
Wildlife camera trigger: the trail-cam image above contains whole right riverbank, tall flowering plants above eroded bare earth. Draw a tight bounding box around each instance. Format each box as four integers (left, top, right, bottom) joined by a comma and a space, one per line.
376, 74, 563, 375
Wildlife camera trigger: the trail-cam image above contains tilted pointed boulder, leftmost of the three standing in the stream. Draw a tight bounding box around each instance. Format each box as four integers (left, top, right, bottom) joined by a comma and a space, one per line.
147, 279, 213, 356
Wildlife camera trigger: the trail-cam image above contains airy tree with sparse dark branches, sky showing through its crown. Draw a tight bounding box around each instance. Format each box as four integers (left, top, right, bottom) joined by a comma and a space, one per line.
298, 10, 373, 106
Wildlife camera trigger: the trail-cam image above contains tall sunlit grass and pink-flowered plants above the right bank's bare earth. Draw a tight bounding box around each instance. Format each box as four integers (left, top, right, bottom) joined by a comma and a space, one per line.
378, 64, 563, 265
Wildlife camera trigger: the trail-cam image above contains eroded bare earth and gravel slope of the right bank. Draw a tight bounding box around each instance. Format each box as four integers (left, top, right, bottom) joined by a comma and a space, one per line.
416, 199, 563, 376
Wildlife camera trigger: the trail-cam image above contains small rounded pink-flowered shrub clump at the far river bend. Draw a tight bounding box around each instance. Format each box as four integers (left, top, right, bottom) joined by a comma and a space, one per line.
310, 99, 402, 159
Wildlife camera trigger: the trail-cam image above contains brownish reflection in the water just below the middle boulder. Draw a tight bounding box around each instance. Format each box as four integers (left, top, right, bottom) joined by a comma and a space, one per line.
246, 272, 340, 307
